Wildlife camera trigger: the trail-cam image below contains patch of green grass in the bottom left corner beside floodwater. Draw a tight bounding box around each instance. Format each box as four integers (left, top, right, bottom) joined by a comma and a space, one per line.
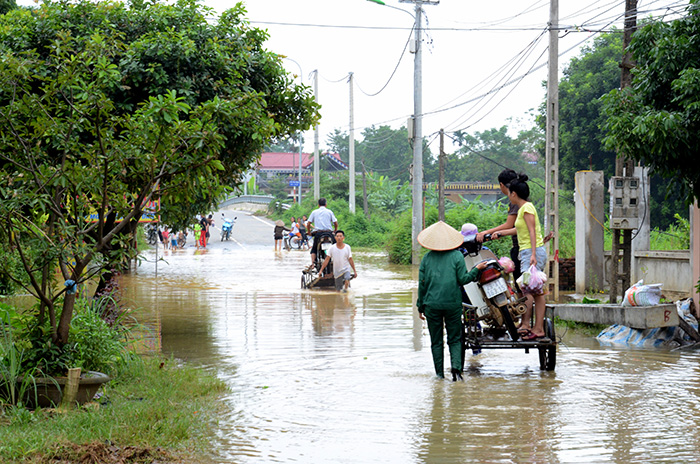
0, 358, 226, 463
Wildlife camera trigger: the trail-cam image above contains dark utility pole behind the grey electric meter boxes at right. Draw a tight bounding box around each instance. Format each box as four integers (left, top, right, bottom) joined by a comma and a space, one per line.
610, 0, 637, 303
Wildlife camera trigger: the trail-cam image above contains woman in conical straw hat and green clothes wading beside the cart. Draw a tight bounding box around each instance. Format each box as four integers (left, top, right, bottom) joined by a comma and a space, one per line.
416, 221, 485, 381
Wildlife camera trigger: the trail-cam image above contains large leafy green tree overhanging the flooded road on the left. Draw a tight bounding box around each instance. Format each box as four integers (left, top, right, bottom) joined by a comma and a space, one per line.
0, 0, 318, 345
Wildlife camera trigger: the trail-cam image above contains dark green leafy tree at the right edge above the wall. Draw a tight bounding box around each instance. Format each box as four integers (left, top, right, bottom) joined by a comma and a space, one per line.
603, 0, 700, 202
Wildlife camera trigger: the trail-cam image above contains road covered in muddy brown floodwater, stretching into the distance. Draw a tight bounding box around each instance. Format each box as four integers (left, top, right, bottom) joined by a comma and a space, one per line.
123, 212, 700, 463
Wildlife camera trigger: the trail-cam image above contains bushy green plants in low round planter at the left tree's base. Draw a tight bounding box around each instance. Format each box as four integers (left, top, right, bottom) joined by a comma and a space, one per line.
0, 297, 132, 408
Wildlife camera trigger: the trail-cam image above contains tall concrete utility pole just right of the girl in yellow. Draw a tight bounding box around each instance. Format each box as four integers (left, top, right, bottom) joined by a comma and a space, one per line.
544, 0, 559, 301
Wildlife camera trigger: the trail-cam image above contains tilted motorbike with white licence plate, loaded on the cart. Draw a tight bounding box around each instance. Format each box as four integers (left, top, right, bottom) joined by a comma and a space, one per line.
460, 234, 527, 341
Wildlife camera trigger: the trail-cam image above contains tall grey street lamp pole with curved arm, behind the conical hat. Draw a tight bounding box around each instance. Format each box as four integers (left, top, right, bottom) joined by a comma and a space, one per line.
367, 0, 439, 264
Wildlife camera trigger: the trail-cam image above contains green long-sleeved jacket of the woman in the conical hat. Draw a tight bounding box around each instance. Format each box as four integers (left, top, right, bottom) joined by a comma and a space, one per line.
416, 250, 479, 313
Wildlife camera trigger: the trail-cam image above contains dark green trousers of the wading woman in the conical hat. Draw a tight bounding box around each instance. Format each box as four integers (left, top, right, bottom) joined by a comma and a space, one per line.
425, 308, 462, 377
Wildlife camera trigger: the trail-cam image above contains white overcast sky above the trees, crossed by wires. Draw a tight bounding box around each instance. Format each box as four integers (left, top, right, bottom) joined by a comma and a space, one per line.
18, 0, 687, 153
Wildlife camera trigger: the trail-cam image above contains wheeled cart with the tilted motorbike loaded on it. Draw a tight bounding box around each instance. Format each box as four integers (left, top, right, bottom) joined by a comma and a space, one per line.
460, 234, 557, 371
